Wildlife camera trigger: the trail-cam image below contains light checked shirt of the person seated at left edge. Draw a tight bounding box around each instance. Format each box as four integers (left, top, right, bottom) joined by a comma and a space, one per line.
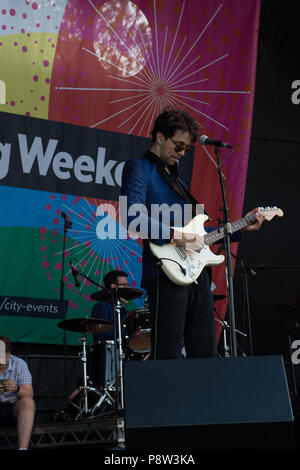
0, 354, 32, 403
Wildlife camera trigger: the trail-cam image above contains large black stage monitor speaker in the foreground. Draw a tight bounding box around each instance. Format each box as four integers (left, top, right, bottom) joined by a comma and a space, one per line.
124, 356, 294, 450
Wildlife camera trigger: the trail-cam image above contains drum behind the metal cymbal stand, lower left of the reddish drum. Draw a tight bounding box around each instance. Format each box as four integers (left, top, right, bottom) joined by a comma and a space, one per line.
90, 340, 116, 390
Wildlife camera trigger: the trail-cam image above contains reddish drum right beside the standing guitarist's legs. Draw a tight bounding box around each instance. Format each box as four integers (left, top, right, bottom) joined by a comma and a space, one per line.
128, 308, 151, 353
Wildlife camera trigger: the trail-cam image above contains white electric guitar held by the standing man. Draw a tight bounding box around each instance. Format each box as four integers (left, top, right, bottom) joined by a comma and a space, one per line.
149, 207, 283, 286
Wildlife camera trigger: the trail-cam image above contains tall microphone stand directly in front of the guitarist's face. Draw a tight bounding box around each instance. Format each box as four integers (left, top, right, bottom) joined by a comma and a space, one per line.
215, 147, 237, 357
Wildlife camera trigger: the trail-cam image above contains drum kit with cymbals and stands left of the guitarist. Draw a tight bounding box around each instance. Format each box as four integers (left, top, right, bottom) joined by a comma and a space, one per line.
58, 287, 151, 421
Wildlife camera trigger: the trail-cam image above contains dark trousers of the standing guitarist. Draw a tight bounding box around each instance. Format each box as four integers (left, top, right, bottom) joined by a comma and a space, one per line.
145, 269, 217, 359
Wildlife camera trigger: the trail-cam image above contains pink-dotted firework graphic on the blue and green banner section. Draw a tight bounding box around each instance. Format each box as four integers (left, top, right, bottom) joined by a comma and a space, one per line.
40, 193, 142, 311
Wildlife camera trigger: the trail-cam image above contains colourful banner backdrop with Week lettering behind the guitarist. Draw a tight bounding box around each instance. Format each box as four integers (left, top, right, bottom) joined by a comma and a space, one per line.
0, 0, 260, 344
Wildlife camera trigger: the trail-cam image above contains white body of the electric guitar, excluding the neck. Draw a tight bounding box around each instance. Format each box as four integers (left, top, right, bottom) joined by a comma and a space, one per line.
150, 214, 225, 286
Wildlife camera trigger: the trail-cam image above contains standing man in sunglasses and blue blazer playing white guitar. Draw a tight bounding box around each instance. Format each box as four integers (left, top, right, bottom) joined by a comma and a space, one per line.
121, 110, 264, 359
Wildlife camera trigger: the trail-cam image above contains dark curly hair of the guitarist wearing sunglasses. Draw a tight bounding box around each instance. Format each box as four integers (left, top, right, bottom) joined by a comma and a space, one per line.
151, 109, 199, 143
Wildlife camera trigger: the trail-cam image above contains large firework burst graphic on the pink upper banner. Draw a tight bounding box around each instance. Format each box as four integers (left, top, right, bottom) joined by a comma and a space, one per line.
53, 0, 250, 136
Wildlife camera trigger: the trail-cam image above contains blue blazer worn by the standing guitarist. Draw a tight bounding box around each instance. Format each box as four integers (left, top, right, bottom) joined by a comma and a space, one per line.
121, 151, 240, 284
